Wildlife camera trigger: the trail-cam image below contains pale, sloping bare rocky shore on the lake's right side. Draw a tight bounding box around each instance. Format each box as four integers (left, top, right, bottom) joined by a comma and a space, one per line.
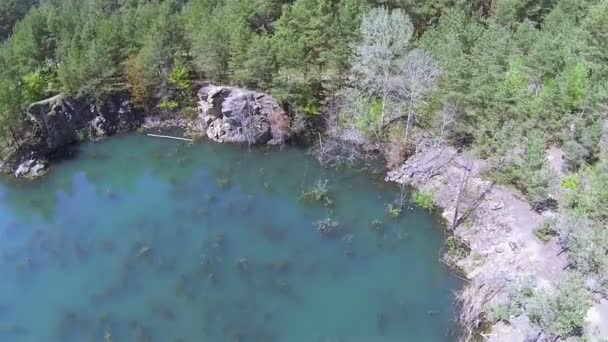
386, 141, 608, 342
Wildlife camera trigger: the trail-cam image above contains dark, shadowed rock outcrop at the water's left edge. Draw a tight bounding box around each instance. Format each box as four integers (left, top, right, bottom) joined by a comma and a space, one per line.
1, 90, 143, 178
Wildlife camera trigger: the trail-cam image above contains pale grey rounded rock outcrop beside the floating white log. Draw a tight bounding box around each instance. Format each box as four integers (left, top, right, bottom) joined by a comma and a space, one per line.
192, 84, 290, 145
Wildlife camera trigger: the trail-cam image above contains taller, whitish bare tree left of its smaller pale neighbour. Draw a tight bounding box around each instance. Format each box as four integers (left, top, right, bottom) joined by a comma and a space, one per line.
353, 7, 414, 125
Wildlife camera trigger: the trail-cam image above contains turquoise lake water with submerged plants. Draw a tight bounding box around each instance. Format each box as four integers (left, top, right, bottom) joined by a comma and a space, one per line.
0, 134, 458, 342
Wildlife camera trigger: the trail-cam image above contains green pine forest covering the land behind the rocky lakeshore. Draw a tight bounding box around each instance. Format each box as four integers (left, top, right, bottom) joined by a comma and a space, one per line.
0, 0, 608, 338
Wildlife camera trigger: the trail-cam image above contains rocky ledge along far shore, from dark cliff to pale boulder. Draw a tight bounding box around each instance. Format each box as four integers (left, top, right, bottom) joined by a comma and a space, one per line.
0, 84, 291, 178
